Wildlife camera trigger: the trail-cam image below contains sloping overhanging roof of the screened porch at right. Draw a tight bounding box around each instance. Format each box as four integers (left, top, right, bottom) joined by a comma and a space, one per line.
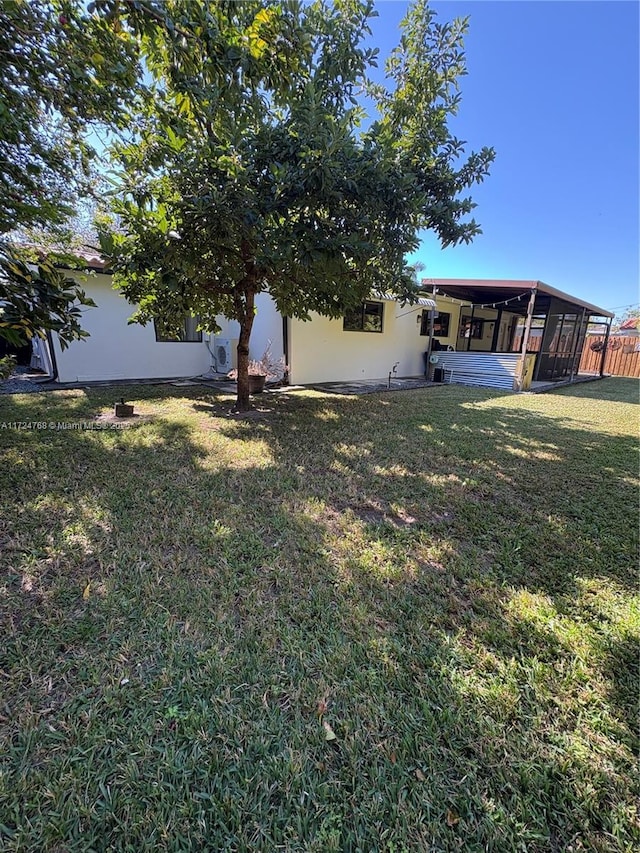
422, 278, 613, 318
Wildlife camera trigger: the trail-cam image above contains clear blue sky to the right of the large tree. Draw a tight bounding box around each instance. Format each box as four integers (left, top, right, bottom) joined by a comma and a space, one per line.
364, 0, 640, 309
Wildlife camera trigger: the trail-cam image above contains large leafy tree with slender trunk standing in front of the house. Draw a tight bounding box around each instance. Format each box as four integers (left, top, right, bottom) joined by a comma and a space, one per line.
103, 0, 493, 410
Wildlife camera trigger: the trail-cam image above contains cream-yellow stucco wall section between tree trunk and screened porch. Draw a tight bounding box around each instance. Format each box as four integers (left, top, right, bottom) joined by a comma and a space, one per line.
289, 299, 459, 384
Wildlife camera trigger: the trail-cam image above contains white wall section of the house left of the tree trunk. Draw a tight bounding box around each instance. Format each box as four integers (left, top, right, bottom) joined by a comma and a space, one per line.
53, 273, 210, 382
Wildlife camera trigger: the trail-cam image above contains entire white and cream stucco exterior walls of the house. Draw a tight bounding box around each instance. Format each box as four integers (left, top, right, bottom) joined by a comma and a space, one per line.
54, 274, 466, 384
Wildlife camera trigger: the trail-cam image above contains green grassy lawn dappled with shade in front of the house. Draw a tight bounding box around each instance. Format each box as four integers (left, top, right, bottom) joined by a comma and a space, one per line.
0, 379, 640, 853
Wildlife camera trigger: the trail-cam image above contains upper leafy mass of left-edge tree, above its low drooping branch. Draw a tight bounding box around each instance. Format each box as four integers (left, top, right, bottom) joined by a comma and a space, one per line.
0, 0, 141, 234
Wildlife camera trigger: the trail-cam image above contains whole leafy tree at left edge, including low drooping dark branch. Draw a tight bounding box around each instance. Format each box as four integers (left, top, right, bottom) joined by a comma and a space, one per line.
0, 0, 144, 346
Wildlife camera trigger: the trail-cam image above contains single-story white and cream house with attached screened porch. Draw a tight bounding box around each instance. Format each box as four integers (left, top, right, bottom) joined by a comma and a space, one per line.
34, 254, 612, 389
